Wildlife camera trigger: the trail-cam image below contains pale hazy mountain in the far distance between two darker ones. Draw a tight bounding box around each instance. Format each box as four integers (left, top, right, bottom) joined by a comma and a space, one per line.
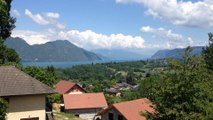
93, 49, 147, 60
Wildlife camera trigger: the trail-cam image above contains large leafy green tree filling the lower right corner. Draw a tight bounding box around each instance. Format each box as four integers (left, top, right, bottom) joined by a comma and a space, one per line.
141, 47, 213, 120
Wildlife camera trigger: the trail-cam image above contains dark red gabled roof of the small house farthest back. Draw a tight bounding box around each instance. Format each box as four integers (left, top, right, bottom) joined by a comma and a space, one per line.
55, 80, 86, 94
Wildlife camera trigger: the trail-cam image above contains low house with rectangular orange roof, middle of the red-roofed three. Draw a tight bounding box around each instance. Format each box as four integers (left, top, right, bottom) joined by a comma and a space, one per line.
63, 93, 107, 120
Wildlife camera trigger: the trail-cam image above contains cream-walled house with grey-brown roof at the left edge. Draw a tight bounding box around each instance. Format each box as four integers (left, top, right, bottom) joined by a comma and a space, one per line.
0, 66, 55, 120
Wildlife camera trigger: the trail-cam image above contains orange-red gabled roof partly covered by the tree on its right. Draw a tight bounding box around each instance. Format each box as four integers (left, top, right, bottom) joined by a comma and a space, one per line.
99, 98, 155, 120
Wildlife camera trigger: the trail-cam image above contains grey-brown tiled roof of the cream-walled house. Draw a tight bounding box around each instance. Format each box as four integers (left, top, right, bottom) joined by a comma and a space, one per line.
0, 66, 54, 96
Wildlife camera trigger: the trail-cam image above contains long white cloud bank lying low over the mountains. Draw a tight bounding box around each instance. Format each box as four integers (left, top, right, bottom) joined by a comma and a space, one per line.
12, 26, 196, 50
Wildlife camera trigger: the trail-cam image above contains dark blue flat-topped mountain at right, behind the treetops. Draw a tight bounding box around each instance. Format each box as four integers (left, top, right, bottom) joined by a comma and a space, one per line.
151, 46, 204, 59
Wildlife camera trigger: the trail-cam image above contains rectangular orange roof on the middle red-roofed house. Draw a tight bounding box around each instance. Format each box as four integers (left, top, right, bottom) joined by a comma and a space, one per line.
63, 93, 107, 109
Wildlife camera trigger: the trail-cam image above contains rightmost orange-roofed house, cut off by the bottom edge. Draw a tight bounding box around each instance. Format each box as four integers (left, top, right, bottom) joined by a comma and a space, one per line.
97, 98, 155, 120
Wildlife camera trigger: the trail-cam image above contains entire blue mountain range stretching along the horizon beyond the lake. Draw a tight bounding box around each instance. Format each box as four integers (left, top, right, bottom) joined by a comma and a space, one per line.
5, 37, 204, 62
